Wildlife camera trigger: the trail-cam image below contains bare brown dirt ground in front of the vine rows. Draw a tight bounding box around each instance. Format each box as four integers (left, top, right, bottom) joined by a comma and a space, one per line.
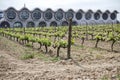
0, 36, 120, 80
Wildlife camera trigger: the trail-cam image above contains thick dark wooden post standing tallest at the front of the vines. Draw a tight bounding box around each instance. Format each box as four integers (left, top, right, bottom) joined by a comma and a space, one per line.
67, 18, 72, 59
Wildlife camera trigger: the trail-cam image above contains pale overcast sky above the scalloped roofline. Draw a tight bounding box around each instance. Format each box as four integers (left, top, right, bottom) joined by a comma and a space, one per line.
0, 0, 120, 20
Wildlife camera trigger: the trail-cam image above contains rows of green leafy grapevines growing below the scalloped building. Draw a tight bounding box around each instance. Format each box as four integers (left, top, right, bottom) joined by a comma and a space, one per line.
0, 25, 120, 54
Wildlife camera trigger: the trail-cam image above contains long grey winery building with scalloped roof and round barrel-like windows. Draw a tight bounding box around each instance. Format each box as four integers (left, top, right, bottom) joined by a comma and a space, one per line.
0, 7, 118, 27
